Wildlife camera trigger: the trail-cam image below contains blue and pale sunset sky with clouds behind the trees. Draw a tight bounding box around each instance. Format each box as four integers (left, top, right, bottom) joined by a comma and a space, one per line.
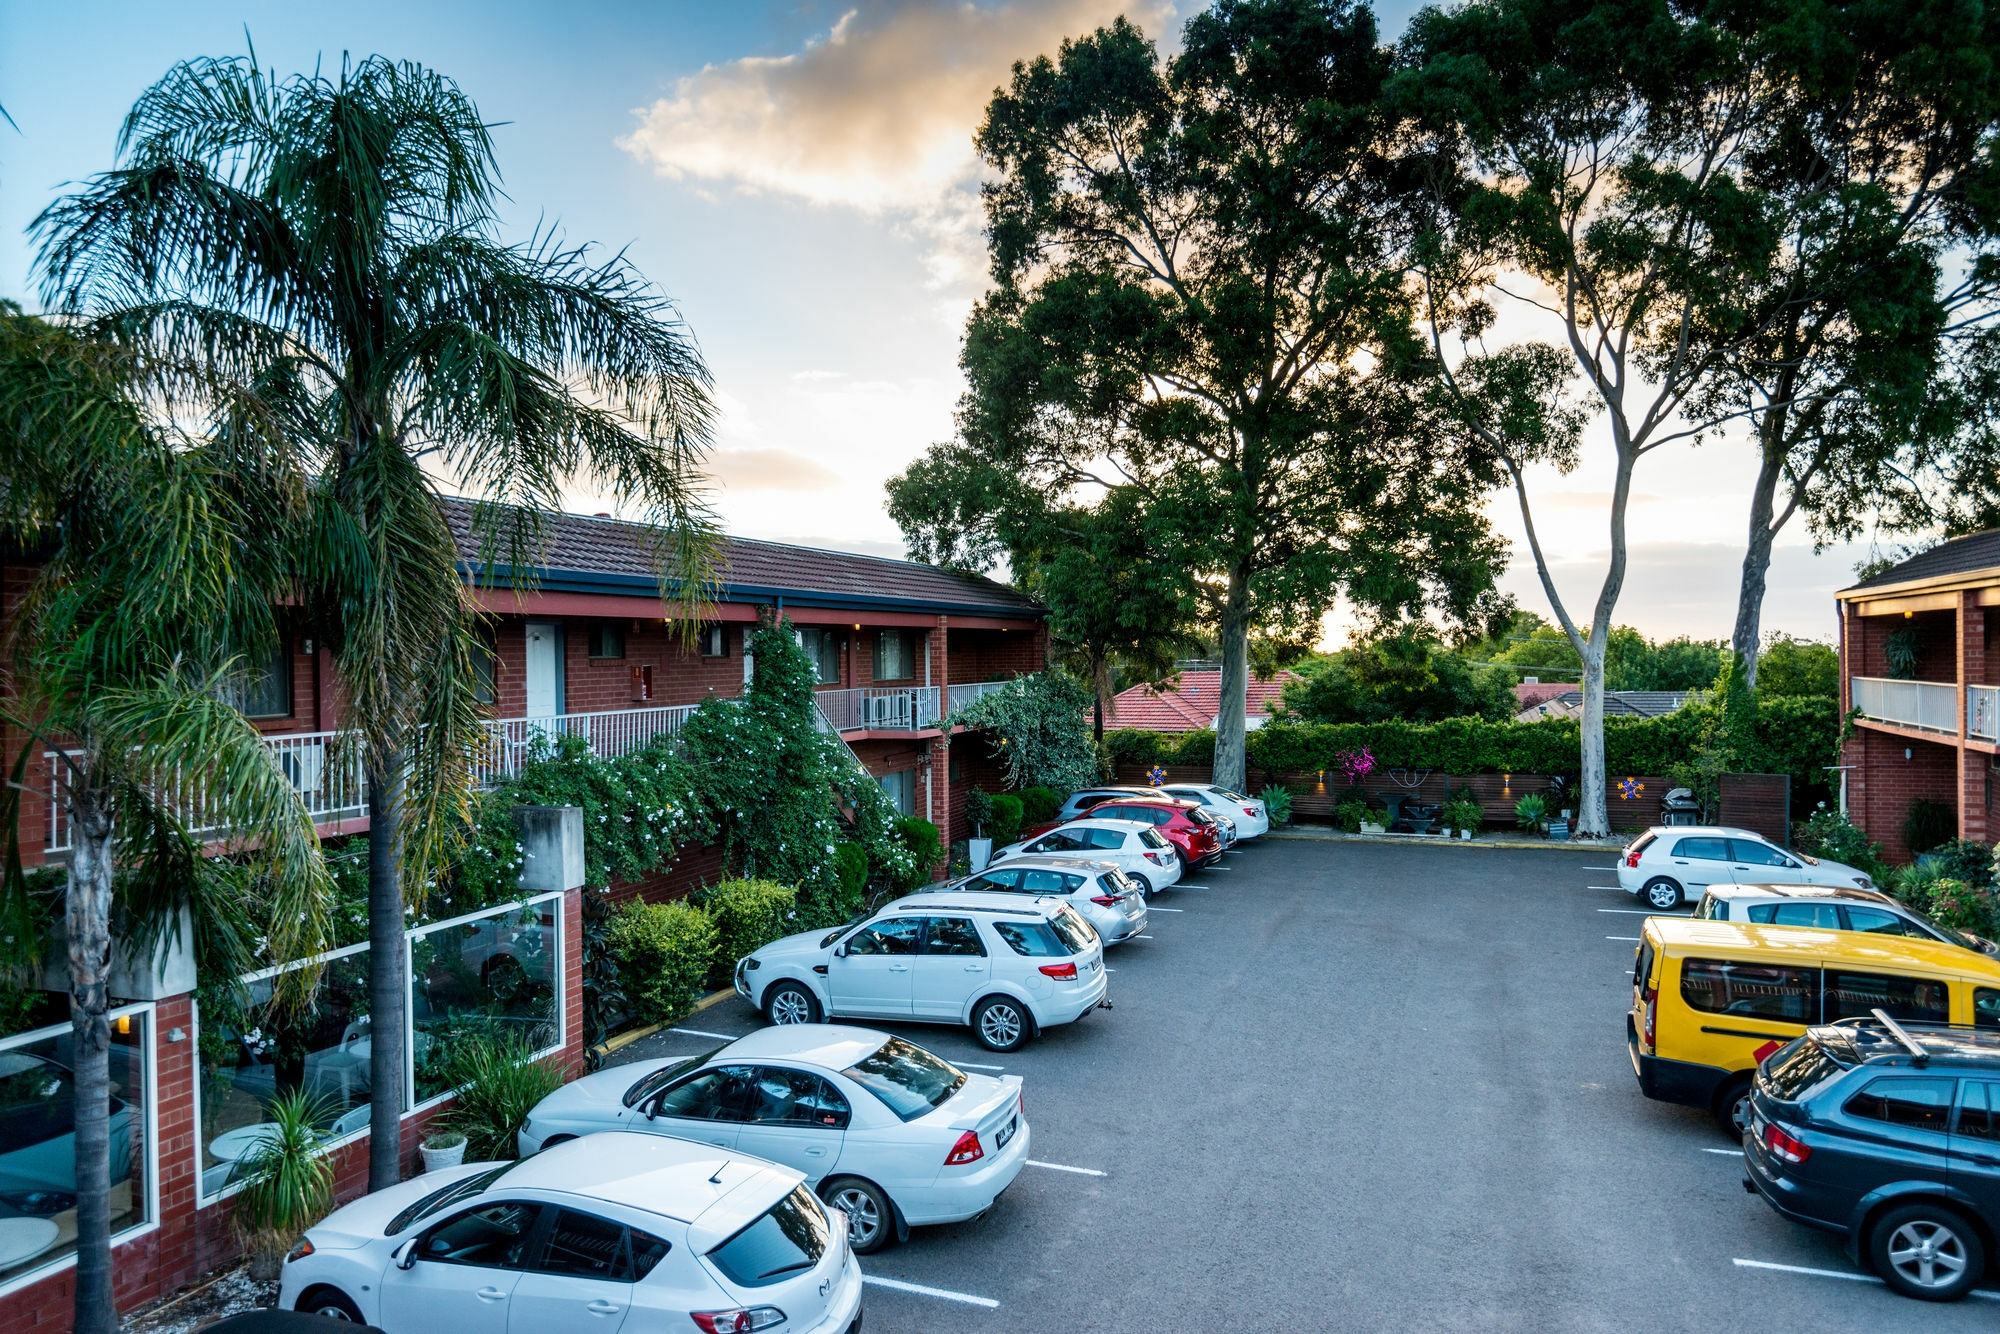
0, 0, 1864, 642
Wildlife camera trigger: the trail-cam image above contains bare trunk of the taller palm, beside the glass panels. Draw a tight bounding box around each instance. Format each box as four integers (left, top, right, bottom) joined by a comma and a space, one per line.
368, 748, 408, 1190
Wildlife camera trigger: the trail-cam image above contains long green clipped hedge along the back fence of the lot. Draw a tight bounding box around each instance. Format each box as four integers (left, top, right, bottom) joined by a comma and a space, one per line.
1104, 698, 1840, 804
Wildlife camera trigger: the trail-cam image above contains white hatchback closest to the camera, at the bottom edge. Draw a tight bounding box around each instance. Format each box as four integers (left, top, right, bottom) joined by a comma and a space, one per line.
278, 1134, 862, 1334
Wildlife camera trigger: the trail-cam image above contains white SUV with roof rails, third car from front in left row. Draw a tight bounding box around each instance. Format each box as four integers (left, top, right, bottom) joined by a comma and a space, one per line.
736, 892, 1106, 1052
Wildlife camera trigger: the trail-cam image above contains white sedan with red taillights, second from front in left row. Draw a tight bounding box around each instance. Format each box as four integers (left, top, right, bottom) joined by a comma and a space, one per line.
520, 1024, 1028, 1254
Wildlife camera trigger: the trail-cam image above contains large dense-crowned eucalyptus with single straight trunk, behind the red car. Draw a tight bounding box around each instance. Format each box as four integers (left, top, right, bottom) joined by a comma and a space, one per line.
904, 0, 1500, 786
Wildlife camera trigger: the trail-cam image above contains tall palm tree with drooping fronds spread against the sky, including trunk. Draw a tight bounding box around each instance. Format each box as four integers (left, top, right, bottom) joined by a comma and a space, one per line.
34, 54, 714, 1188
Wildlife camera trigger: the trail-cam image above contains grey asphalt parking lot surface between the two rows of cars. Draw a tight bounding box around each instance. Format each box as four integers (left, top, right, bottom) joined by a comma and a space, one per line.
620, 840, 2000, 1334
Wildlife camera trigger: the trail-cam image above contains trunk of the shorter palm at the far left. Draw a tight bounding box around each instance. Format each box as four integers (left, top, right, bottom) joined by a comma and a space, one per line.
64, 796, 118, 1334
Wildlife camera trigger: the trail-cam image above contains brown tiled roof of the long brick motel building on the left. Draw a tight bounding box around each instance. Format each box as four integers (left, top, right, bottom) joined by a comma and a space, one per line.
444, 498, 1044, 616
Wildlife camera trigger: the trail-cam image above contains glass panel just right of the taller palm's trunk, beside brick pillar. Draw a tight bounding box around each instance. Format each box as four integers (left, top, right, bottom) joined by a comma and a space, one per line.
410, 900, 560, 1102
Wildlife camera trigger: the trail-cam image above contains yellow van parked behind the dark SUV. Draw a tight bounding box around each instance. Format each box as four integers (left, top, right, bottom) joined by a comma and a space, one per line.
1626, 918, 2000, 1136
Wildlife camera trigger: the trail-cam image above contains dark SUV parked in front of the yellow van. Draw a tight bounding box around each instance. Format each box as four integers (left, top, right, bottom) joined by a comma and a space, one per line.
1744, 1010, 2000, 1302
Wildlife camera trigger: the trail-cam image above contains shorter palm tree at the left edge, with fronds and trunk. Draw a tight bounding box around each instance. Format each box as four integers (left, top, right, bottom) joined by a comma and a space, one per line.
0, 304, 328, 1334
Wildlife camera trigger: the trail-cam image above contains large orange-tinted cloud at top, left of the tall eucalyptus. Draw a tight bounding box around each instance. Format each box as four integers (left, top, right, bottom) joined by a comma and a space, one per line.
618, 0, 1174, 286
